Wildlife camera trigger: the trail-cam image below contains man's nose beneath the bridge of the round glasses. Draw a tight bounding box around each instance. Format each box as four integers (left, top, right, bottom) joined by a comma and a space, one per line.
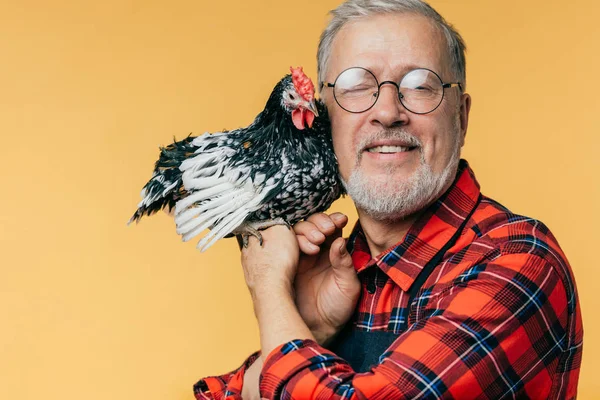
371, 81, 408, 127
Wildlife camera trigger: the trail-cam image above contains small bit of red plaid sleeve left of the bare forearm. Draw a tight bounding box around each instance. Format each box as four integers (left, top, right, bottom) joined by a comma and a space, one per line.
194, 351, 260, 400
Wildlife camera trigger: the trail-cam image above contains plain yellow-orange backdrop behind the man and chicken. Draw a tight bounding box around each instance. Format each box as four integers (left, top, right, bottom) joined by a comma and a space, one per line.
0, 0, 600, 400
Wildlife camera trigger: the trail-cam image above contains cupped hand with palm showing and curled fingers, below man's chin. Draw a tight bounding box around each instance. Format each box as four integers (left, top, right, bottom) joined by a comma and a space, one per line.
294, 213, 361, 345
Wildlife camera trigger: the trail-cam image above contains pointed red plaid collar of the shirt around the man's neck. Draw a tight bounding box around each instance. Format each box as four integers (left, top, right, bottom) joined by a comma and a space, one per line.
348, 159, 480, 292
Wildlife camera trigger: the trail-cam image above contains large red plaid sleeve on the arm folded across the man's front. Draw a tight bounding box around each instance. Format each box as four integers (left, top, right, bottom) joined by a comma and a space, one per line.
259, 254, 579, 400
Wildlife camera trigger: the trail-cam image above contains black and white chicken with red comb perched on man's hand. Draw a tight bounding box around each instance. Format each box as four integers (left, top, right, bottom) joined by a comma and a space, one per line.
128, 67, 344, 251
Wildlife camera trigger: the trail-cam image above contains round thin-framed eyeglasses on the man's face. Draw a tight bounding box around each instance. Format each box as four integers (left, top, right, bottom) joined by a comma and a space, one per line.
321, 67, 462, 114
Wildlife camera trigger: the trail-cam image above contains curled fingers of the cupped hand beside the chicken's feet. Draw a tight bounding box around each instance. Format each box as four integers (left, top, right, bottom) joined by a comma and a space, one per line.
294, 213, 348, 255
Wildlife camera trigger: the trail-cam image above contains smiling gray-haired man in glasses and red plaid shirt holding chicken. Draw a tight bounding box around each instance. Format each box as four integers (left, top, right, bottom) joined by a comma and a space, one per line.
194, 0, 583, 399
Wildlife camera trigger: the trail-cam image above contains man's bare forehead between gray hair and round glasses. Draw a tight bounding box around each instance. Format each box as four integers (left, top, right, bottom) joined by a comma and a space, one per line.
327, 14, 448, 79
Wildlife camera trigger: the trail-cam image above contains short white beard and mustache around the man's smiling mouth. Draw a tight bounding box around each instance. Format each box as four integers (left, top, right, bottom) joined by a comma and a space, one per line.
342, 116, 461, 221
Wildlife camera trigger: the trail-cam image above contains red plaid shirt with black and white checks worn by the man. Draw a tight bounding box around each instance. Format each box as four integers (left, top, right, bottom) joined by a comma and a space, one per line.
194, 160, 583, 399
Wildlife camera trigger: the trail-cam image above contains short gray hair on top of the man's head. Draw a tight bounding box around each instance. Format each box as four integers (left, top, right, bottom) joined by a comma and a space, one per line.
317, 0, 467, 90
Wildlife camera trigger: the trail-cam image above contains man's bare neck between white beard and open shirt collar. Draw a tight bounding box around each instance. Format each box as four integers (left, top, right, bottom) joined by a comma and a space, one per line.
357, 210, 422, 257
